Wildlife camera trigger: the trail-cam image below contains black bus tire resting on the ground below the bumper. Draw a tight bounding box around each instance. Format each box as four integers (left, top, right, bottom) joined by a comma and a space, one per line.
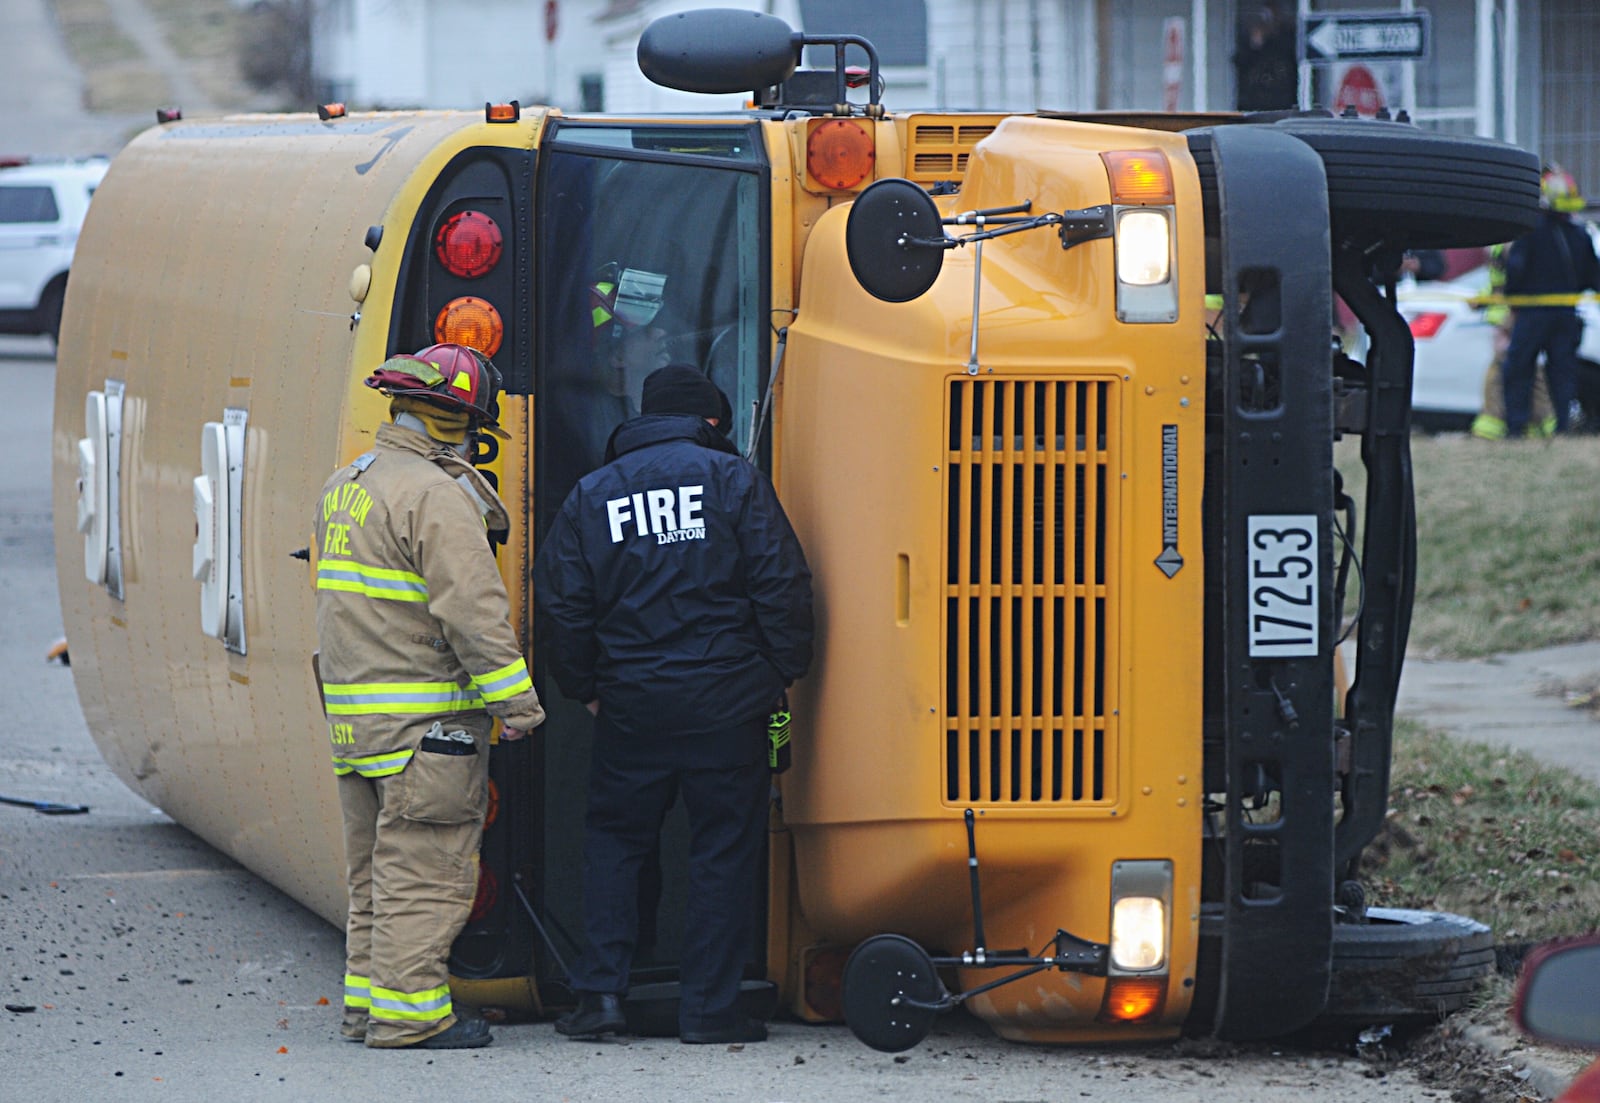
1317, 908, 1494, 1029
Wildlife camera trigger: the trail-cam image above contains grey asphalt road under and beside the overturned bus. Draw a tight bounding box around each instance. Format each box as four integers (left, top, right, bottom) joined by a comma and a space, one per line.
0, 348, 1450, 1103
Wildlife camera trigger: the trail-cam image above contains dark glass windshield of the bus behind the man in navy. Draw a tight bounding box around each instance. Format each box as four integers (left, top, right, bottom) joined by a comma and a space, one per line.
530, 120, 771, 1005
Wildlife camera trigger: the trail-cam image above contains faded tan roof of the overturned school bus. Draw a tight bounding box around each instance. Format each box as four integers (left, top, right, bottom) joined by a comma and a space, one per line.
53, 112, 541, 924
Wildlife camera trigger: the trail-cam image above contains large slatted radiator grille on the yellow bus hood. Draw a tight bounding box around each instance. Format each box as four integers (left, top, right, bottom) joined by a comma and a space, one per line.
941, 379, 1122, 807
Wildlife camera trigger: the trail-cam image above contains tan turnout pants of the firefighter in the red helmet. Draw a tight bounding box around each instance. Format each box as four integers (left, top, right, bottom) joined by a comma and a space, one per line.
339, 717, 490, 1049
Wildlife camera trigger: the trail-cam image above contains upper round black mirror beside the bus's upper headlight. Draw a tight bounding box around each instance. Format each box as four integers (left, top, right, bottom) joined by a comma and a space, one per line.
845, 178, 954, 303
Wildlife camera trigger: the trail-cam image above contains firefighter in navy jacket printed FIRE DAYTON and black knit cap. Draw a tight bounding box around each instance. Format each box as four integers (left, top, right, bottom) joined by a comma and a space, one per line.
534, 363, 811, 1044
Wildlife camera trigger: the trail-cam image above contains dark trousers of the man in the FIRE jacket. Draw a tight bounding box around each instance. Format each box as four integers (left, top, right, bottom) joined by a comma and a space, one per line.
573, 709, 771, 1031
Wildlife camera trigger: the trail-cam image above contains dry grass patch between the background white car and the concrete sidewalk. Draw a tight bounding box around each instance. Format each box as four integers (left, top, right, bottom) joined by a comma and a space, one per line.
1334, 435, 1600, 658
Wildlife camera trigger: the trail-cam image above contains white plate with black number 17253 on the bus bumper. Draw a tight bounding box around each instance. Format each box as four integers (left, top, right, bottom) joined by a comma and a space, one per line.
1250, 514, 1318, 658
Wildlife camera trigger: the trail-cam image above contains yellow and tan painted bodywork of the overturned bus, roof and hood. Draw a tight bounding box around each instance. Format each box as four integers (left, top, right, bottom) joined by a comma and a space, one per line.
53, 98, 1205, 1041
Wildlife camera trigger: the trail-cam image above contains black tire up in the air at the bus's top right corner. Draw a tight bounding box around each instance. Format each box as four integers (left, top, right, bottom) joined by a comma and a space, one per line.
1190, 115, 1539, 250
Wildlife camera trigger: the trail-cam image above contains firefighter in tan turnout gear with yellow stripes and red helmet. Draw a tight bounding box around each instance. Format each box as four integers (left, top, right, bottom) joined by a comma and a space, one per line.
314, 344, 544, 1049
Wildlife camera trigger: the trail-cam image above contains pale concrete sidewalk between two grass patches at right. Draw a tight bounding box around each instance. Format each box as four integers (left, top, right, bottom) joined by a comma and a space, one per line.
1397, 642, 1600, 783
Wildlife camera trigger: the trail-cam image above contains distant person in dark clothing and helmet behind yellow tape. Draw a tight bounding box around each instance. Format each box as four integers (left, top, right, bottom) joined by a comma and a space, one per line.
1502, 166, 1600, 437
